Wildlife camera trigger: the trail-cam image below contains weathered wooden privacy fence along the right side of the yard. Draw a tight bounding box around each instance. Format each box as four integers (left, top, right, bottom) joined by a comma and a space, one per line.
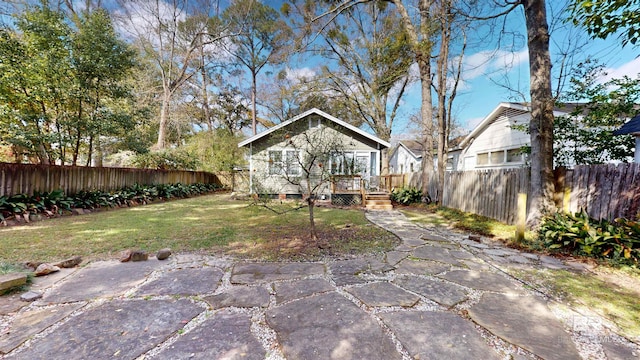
404, 164, 640, 224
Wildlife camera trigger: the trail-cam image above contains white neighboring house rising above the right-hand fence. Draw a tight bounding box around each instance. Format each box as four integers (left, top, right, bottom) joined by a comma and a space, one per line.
457, 103, 574, 170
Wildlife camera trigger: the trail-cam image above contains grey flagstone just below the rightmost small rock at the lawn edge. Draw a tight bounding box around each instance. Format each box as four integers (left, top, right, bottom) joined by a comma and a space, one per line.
137, 267, 224, 295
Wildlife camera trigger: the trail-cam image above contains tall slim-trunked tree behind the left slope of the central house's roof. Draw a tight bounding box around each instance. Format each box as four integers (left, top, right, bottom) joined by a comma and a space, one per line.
222, 0, 291, 134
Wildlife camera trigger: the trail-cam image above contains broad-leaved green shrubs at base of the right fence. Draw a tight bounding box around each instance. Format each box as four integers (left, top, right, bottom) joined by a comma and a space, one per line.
539, 211, 640, 264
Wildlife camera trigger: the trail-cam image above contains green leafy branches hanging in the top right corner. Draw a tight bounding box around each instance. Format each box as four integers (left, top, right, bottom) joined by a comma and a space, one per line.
569, 0, 640, 45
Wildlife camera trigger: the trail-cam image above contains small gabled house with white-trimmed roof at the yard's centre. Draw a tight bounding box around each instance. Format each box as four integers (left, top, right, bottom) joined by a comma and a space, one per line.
238, 108, 390, 196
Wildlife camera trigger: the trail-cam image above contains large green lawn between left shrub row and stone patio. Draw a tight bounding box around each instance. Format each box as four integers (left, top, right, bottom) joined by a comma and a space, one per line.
0, 194, 398, 263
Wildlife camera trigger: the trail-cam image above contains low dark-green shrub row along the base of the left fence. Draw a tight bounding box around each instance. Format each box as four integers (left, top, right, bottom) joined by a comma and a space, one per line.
0, 183, 221, 222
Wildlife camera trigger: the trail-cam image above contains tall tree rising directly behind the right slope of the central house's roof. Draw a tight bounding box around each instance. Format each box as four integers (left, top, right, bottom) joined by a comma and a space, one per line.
312, 1, 414, 174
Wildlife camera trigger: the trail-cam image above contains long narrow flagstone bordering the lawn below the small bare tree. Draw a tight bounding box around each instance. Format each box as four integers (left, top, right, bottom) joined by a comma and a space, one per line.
231, 263, 325, 284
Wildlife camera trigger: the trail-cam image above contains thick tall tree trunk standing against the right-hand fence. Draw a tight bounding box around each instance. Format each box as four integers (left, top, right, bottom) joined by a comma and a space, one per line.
522, 0, 554, 227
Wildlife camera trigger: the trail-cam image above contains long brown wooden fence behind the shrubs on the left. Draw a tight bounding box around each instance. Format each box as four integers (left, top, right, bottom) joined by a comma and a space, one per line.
0, 163, 222, 196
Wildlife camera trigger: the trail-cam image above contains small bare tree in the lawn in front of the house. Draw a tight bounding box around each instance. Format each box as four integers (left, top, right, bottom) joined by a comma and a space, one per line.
256, 118, 353, 247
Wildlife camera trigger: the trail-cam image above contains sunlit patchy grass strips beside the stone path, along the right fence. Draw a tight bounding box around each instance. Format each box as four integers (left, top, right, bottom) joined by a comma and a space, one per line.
401, 205, 640, 341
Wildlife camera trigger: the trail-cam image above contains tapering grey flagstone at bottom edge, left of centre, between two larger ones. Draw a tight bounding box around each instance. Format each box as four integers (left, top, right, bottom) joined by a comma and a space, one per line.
155, 313, 266, 360
